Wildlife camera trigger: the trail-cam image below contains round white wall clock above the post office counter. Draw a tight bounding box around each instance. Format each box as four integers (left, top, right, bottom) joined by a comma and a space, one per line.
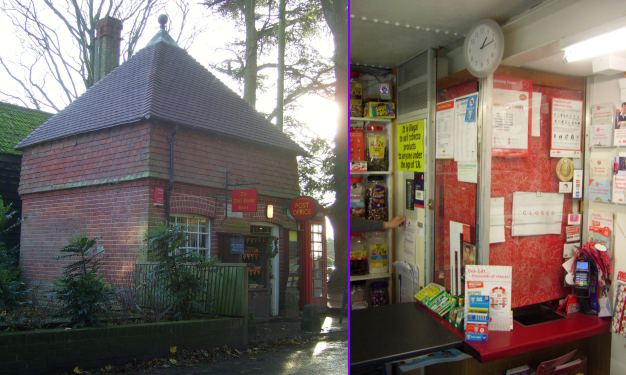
463, 19, 504, 78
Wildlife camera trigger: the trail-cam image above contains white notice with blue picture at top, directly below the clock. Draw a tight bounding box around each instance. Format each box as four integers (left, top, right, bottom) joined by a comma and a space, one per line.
454, 93, 478, 162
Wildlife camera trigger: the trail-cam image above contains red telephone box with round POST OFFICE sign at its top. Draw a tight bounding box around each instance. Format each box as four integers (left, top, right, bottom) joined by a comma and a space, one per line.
289, 197, 328, 308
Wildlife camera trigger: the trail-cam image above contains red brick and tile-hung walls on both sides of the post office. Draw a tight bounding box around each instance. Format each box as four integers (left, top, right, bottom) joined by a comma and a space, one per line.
20, 123, 298, 285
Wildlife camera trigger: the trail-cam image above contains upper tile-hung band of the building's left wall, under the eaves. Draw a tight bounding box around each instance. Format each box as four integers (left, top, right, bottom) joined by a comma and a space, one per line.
19, 123, 150, 195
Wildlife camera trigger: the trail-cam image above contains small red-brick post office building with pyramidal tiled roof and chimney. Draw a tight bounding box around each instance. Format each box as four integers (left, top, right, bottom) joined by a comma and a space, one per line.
17, 18, 304, 316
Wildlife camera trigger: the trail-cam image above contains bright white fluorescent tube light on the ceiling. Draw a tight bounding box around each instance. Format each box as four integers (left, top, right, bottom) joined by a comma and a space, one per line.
563, 27, 626, 63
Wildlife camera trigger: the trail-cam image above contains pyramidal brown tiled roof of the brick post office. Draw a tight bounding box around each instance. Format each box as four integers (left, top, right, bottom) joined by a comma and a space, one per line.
17, 41, 305, 155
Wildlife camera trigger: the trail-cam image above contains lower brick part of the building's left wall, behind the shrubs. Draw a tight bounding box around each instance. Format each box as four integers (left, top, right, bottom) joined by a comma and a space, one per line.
20, 180, 150, 285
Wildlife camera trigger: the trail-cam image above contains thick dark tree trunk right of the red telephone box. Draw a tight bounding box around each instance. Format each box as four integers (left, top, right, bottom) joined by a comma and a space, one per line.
321, 0, 350, 289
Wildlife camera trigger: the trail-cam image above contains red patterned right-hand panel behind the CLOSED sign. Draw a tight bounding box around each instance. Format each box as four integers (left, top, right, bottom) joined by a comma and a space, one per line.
489, 86, 584, 307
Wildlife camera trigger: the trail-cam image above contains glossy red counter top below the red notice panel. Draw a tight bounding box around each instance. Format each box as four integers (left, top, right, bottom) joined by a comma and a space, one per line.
465, 313, 611, 362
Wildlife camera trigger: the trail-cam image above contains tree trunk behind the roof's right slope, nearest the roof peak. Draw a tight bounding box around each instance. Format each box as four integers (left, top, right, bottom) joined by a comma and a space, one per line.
243, 0, 259, 108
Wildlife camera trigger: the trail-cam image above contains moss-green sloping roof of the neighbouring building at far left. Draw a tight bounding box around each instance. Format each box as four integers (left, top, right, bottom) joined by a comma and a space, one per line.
0, 103, 52, 155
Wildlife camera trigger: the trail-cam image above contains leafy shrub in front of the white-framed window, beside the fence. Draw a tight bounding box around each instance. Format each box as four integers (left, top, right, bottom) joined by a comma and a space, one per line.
146, 225, 200, 319
